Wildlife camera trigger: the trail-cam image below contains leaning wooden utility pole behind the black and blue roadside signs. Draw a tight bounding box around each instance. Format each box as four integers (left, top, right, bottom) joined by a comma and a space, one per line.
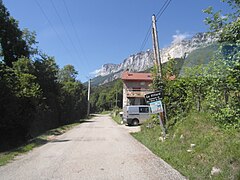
152, 15, 166, 139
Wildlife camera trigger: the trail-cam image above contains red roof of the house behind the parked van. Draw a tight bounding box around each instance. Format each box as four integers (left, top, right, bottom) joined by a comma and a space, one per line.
122, 71, 152, 81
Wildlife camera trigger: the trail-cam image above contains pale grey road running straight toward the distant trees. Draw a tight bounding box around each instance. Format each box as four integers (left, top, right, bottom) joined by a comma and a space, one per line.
0, 115, 185, 180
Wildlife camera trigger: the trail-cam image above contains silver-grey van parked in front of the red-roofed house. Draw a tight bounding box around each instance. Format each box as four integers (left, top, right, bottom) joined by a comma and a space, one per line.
123, 105, 151, 126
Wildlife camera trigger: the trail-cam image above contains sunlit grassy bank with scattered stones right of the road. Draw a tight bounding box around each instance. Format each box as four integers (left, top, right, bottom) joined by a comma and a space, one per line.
132, 113, 240, 179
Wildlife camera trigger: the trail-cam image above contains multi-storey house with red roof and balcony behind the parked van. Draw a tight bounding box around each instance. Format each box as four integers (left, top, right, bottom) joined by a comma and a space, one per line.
122, 71, 152, 108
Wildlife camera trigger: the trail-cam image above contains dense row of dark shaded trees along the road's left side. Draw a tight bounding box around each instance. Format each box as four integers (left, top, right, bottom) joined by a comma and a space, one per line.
0, 1, 87, 150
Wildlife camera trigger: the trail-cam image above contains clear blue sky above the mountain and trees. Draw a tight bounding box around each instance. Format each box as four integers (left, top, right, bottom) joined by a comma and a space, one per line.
3, 0, 230, 82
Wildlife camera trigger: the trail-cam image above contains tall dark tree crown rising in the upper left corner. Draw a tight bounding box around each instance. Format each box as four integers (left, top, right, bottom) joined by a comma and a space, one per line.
0, 0, 29, 67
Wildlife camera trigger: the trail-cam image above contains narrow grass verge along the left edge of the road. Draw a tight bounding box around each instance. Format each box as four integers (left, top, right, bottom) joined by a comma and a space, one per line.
0, 118, 89, 166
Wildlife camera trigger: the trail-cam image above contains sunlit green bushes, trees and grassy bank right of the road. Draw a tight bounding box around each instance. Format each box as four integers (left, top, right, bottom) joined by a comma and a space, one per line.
133, 1, 240, 179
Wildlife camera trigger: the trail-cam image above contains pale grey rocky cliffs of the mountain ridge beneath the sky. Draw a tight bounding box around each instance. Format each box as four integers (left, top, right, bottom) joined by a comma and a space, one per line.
92, 33, 217, 85
